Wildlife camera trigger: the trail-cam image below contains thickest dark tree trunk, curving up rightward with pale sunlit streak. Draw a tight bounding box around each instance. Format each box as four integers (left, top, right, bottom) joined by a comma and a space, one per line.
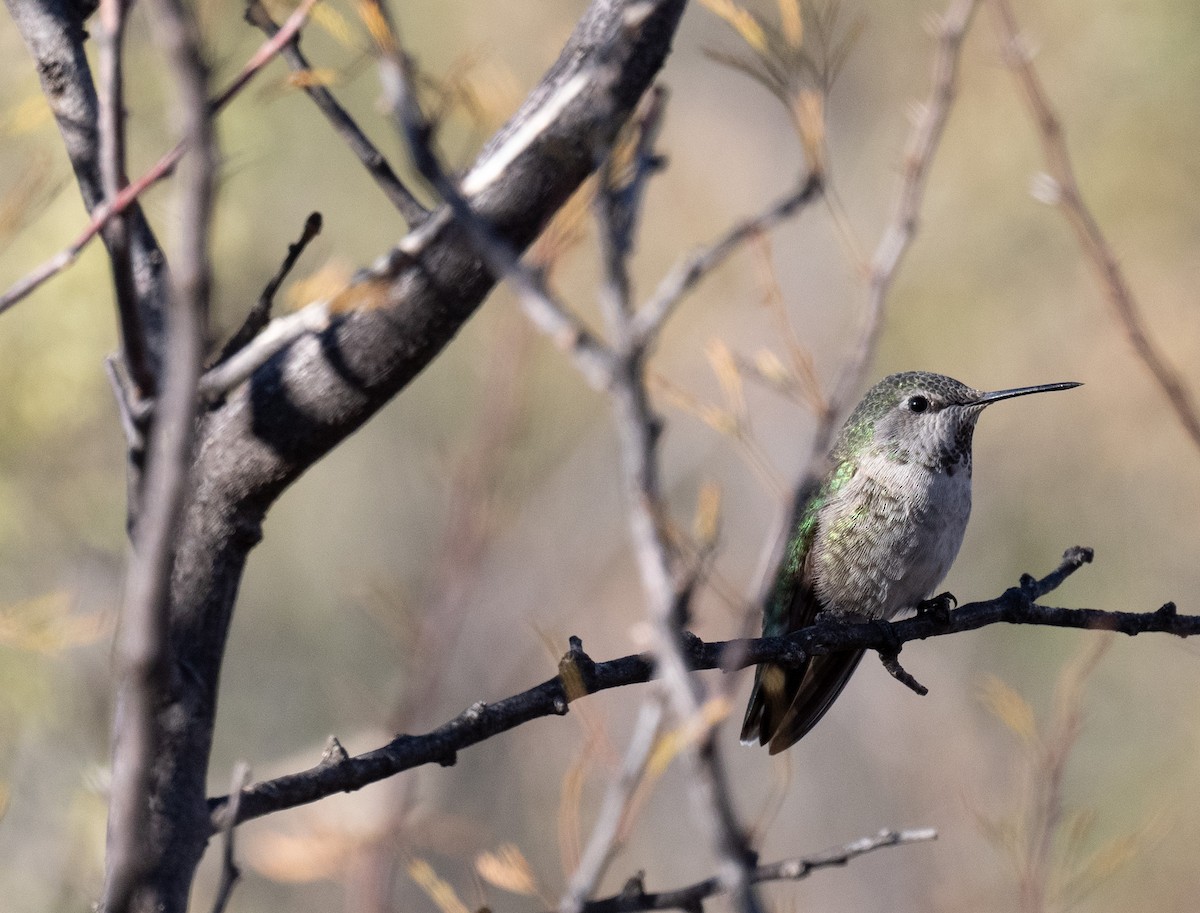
70, 0, 685, 913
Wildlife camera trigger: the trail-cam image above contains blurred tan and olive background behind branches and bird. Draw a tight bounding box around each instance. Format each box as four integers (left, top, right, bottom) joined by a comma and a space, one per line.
0, 0, 1200, 913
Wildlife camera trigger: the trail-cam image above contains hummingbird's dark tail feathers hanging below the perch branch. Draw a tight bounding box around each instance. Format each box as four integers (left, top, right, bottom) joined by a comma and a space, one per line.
742, 650, 863, 755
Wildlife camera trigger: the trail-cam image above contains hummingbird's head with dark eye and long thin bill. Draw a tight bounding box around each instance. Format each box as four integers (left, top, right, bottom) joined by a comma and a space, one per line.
834, 371, 1079, 473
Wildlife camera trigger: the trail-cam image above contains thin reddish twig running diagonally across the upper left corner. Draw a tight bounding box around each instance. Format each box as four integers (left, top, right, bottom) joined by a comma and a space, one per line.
0, 0, 317, 314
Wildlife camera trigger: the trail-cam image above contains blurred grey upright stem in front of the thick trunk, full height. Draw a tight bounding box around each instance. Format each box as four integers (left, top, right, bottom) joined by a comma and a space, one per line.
103, 0, 216, 913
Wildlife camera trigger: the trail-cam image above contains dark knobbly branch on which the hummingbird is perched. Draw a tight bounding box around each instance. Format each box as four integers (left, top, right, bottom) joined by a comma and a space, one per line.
209, 547, 1200, 833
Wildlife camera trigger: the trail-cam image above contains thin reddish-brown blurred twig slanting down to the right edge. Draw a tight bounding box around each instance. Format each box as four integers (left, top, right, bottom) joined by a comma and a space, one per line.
991, 0, 1200, 448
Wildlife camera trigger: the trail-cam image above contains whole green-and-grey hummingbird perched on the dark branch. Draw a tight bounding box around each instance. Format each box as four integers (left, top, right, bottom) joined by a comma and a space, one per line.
742, 371, 1079, 755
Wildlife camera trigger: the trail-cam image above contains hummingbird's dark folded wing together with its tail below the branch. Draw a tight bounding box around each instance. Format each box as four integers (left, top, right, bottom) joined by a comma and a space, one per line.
742, 464, 863, 755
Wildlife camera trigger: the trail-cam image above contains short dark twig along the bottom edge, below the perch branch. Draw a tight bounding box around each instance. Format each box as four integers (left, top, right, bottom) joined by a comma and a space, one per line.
571, 828, 937, 913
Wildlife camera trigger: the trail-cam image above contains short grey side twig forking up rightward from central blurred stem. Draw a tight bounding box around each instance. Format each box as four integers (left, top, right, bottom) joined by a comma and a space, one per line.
634, 172, 824, 340
